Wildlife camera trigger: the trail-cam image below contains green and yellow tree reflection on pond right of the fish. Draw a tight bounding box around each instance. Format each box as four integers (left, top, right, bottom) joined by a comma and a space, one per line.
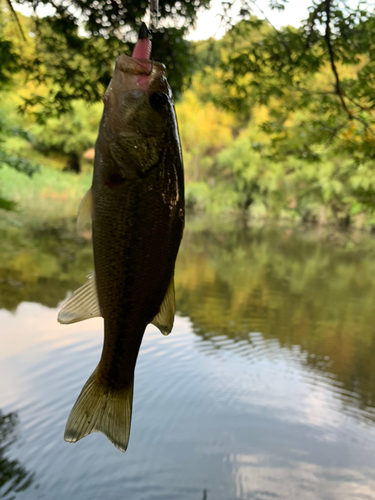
176, 228, 375, 420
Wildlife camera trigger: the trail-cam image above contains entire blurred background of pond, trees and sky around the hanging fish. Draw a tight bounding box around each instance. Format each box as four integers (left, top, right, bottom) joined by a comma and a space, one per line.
0, 0, 375, 500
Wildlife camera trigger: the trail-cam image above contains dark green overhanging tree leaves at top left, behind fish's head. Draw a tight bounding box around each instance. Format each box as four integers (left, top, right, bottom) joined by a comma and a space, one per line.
0, 0, 210, 120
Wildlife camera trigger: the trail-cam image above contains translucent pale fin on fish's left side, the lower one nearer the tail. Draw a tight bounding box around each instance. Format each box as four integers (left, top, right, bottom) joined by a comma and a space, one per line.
57, 272, 101, 325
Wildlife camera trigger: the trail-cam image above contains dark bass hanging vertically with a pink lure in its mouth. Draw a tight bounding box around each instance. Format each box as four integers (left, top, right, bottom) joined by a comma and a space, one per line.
58, 25, 185, 452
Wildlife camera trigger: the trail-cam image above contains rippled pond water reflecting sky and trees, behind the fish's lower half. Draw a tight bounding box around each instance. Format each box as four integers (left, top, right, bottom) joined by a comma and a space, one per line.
0, 221, 375, 500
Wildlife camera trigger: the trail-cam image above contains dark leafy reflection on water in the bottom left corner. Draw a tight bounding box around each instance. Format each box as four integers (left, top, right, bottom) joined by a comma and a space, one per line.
0, 410, 34, 500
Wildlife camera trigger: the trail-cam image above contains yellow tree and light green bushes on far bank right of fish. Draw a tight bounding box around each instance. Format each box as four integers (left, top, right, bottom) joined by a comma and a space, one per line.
177, 51, 375, 226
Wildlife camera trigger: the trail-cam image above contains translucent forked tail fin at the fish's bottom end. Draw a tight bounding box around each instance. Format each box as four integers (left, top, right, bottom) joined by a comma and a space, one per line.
64, 370, 133, 452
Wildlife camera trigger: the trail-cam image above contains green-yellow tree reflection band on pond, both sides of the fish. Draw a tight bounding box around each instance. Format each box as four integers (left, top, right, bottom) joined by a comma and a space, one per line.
0, 224, 375, 420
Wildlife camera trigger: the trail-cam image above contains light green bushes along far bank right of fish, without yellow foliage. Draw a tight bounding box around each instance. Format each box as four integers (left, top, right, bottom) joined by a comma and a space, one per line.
186, 109, 375, 226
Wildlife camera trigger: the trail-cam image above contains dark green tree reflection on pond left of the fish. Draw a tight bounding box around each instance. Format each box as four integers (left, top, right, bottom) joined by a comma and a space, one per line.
0, 227, 92, 311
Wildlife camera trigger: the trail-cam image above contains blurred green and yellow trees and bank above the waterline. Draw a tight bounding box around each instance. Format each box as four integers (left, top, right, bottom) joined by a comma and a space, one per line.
0, 0, 375, 228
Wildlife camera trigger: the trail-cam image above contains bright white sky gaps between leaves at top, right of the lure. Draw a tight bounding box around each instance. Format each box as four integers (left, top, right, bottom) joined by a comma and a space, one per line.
188, 0, 312, 41
